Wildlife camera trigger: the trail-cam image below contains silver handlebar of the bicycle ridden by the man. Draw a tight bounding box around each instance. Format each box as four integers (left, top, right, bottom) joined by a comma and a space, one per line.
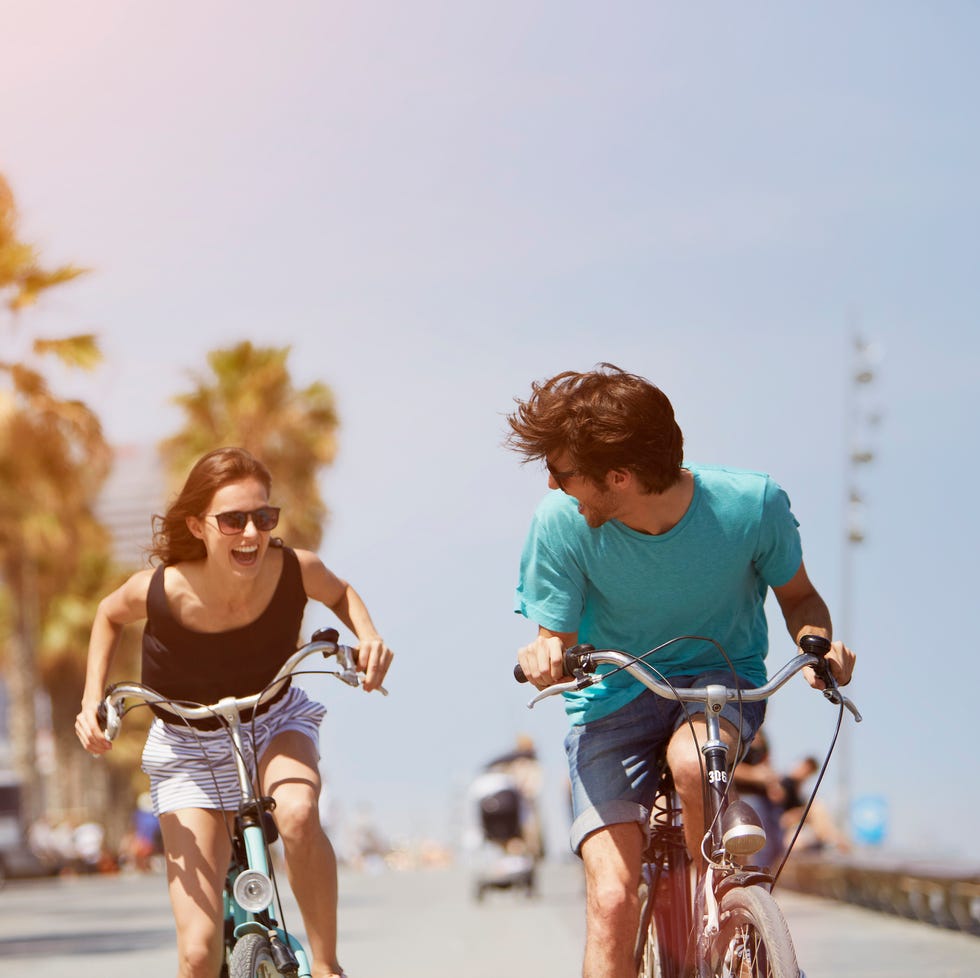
514, 635, 862, 723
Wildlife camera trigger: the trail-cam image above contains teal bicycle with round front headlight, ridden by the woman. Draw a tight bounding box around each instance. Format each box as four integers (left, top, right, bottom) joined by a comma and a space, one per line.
98, 628, 378, 978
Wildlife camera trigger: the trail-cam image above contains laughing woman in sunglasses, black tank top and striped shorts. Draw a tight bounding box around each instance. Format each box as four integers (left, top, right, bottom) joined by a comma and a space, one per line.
75, 448, 392, 978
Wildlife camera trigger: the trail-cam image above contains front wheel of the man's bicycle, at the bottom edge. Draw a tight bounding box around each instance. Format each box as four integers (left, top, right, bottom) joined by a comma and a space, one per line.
705, 886, 800, 978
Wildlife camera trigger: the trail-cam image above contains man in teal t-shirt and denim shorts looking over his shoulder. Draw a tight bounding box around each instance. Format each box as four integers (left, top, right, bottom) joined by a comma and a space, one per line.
508, 364, 854, 978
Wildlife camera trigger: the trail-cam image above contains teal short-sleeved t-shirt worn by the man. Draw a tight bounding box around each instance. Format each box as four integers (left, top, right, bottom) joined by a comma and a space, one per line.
514, 465, 803, 723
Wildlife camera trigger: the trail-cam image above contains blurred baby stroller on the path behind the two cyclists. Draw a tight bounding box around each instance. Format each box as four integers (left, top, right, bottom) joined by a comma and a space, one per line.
471, 772, 534, 900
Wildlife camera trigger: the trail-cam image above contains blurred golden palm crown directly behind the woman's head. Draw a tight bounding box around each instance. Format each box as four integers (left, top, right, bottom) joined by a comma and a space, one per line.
160, 341, 338, 550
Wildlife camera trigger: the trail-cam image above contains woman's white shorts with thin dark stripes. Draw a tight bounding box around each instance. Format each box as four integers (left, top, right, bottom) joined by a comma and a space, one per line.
142, 686, 327, 815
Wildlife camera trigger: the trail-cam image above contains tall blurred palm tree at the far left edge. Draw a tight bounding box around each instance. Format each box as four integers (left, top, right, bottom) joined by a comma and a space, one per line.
0, 177, 110, 819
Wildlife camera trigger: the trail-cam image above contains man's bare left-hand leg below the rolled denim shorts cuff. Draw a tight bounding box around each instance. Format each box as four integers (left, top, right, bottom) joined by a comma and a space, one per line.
581, 822, 645, 978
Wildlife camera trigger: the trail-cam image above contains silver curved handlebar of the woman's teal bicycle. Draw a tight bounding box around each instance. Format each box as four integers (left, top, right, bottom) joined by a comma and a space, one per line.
96, 628, 388, 740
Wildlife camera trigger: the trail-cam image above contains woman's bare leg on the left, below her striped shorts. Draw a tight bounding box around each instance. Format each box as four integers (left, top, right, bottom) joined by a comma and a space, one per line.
160, 808, 231, 978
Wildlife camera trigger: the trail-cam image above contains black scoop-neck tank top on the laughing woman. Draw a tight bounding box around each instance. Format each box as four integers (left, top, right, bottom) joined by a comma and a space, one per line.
142, 547, 306, 730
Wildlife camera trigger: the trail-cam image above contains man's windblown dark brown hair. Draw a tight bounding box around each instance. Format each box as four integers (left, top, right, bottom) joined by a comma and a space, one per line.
507, 363, 684, 493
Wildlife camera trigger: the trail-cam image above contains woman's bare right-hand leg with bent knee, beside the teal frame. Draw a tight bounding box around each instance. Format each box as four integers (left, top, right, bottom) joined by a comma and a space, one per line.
259, 730, 343, 978
